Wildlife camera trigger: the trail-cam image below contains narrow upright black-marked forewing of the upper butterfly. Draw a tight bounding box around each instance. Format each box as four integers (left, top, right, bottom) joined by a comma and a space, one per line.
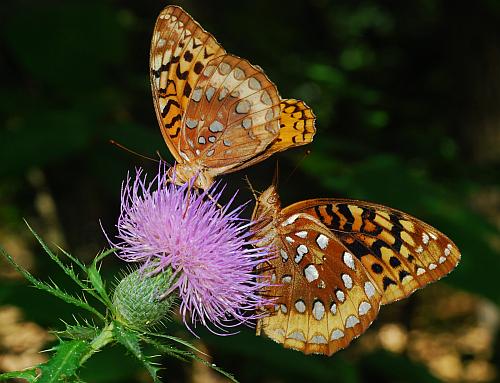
150, 5, 226, 162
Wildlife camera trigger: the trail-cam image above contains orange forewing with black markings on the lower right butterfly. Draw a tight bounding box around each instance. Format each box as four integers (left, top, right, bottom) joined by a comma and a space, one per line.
284, 199, 460, 304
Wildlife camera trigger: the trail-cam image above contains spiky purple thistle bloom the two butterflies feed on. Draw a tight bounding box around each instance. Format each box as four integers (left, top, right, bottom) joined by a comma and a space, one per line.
111, 165, 271, 331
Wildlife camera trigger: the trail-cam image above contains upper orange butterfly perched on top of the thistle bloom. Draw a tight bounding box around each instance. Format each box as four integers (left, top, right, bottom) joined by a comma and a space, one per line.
150, 6, 316, 189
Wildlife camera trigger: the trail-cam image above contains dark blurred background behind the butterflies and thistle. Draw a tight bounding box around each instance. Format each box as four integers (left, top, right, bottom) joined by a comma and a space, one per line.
0, 0, 500, 383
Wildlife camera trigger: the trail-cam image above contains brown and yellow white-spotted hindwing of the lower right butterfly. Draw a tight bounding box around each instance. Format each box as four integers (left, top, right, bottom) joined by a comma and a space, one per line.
257, 212, 382, 355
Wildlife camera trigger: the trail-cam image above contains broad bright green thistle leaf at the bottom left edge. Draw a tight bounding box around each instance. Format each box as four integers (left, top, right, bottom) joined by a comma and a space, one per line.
37, 340, 91, 383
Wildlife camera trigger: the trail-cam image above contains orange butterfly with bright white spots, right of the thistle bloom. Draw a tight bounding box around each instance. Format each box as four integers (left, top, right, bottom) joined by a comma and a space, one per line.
253, 186, 460, 355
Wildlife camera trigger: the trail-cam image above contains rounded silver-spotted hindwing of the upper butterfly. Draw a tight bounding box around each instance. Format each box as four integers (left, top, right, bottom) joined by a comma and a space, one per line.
183, 54, 280, 166
